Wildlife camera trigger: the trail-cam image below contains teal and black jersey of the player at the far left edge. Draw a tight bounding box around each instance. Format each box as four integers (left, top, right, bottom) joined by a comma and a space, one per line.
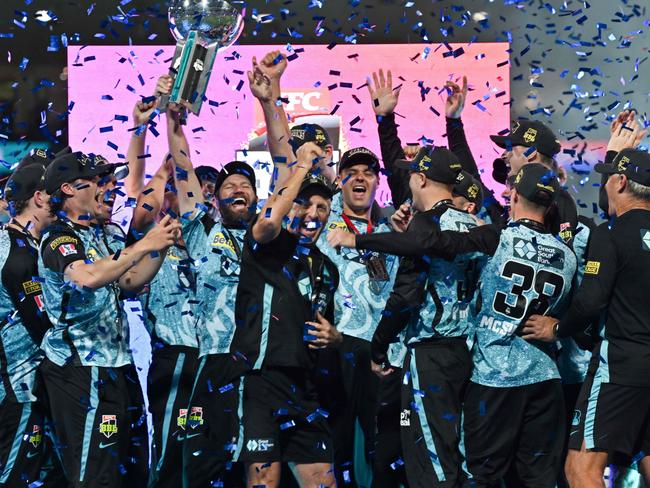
0, 227, 51, 403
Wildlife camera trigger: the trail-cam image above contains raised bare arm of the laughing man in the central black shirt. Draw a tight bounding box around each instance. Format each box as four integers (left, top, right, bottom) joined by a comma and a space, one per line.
252, 142, 324, 244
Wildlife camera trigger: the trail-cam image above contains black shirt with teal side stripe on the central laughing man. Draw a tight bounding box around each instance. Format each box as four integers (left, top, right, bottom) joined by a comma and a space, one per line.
230, 225, 339, 369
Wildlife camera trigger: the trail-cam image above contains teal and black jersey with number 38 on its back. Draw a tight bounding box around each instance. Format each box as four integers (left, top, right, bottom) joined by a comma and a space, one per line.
357, 220, 576, 387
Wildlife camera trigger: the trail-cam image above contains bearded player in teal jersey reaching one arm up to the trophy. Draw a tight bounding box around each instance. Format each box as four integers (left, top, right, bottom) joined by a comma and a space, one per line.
167, 105, 257, 487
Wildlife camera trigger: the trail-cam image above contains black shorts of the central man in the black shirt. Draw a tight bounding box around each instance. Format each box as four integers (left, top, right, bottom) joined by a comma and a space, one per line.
239, 368, 333, 464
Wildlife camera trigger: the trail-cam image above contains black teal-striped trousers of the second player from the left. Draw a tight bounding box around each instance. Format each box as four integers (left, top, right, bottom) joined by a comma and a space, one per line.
39, 359, 149, 488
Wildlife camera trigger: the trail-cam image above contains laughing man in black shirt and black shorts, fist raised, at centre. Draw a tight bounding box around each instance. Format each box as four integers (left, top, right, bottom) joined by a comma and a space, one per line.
231, 142, 341, 488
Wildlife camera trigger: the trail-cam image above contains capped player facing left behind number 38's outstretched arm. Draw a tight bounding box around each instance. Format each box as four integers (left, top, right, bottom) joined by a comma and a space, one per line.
330, 146, 478, 486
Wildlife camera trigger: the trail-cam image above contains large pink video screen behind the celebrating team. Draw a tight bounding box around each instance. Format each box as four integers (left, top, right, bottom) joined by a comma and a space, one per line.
68, 43, 510, 204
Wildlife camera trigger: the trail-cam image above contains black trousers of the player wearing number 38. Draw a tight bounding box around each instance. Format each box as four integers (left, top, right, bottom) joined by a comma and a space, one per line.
463, 380, 565, 488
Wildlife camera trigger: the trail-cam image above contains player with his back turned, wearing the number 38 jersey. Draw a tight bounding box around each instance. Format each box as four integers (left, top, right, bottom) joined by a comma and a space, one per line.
335, 164, 576, 487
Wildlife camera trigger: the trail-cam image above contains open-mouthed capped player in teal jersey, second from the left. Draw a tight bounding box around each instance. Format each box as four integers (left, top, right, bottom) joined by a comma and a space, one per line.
39, 153, 180, 487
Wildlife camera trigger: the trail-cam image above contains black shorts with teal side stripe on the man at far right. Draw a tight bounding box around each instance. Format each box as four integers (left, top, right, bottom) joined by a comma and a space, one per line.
569, 357, 650, 465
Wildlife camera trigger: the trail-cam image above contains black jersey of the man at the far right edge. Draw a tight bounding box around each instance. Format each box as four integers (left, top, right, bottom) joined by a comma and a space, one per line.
559, 209, 650, 387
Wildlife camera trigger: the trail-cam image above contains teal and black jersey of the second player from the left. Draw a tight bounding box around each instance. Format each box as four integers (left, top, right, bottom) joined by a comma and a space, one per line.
38, 220, 132, 367
